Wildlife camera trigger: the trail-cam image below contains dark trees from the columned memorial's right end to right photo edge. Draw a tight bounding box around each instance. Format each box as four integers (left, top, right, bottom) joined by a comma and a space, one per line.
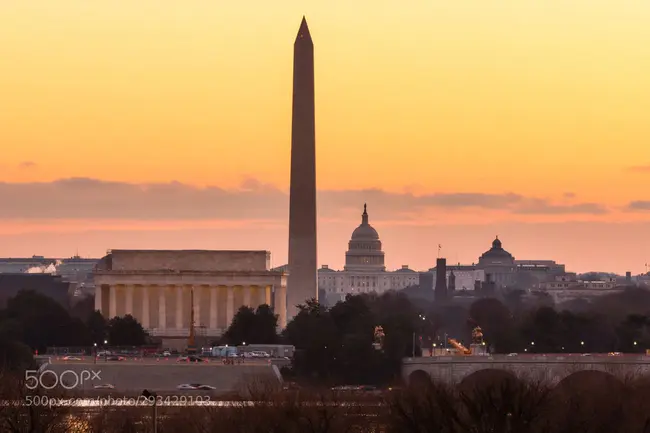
222, 288, 650, 385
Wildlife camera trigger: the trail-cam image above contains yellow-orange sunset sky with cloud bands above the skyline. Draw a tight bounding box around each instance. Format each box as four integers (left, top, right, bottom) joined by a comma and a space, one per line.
0, 0, 650, 273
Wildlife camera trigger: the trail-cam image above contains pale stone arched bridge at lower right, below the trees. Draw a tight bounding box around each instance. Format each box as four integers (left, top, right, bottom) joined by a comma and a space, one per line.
402, 353, 650, 385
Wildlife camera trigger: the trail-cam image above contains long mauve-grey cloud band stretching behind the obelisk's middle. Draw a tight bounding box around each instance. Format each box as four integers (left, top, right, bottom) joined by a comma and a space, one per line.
0, 178, 608, 221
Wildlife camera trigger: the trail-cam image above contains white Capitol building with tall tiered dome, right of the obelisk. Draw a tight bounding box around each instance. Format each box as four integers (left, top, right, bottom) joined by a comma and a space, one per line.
318, 204, 420, 304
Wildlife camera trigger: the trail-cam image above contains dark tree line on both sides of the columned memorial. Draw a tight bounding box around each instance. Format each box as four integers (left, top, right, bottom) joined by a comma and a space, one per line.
0, 288, 650, 385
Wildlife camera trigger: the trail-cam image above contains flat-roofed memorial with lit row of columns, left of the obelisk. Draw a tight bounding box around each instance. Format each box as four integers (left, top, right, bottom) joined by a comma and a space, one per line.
94, 250, 287, 339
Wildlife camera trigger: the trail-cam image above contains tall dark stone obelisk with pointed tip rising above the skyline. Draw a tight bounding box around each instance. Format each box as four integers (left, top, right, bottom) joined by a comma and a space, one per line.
287, 17, 318, 318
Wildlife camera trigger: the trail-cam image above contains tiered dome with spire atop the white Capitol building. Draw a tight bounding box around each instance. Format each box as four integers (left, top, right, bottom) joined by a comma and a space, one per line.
345, 204, 386, 272
